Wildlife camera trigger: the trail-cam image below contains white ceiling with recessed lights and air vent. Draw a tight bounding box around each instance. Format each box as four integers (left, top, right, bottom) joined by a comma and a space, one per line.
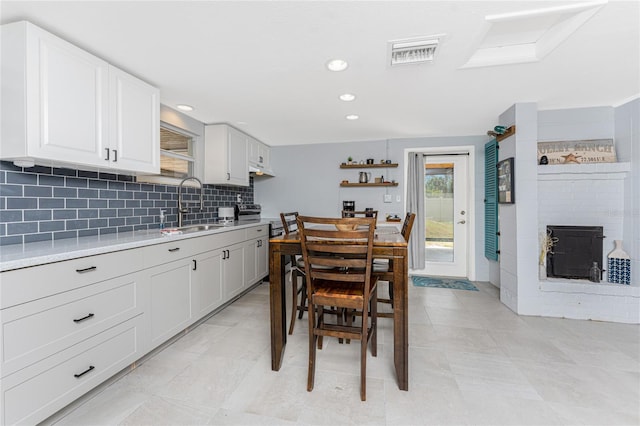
0, 0, 640, 146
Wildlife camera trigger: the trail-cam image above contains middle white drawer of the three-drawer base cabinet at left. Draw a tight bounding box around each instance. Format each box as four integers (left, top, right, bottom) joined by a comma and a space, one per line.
0, 274, 142, 377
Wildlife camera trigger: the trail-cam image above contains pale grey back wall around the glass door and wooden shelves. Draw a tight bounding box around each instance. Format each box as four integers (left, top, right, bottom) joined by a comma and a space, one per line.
254, 136, 489, 281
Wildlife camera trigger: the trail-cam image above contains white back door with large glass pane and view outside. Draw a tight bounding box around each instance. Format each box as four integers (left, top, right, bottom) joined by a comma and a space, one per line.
424, 155, 470, 277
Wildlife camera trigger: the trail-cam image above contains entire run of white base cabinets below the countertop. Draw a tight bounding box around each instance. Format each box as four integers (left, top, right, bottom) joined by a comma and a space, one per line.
0, 225, 268, 425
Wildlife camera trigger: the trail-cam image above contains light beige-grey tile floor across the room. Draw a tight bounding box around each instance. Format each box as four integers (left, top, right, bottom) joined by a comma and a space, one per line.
51, 283, 640, 425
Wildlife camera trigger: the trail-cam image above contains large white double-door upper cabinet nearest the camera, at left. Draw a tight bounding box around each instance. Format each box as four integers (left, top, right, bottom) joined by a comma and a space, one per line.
0, 22, 160, 173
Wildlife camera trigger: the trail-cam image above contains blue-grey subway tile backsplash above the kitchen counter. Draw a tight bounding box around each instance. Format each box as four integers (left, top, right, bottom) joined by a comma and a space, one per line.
0, 161, 253, 245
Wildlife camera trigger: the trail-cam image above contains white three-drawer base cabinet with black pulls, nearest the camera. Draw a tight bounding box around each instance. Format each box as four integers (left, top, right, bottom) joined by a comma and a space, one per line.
0, 250, 148, 424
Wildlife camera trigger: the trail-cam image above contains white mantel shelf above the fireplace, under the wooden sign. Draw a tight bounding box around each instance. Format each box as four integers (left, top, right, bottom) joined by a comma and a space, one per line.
538, 163, 631, 180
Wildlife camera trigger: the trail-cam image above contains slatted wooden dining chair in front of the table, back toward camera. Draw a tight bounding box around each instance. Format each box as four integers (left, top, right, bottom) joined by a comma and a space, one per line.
298, 216, 377, 401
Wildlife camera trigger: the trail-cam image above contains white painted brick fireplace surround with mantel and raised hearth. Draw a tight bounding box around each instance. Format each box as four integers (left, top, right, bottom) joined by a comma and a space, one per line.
538, 163, 640, 322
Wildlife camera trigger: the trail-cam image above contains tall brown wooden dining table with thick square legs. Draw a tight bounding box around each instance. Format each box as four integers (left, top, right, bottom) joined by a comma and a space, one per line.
269, 226, 409, 390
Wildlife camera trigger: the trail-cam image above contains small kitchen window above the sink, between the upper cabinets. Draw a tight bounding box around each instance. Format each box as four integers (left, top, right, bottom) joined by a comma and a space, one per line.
160, 123, 194, 179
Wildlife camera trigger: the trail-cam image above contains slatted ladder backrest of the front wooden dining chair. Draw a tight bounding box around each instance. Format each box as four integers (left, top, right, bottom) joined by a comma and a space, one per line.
298, 216, 376, 300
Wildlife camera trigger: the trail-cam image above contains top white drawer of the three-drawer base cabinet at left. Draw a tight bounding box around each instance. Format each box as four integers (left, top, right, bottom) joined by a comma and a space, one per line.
0, 250, 142, 309
